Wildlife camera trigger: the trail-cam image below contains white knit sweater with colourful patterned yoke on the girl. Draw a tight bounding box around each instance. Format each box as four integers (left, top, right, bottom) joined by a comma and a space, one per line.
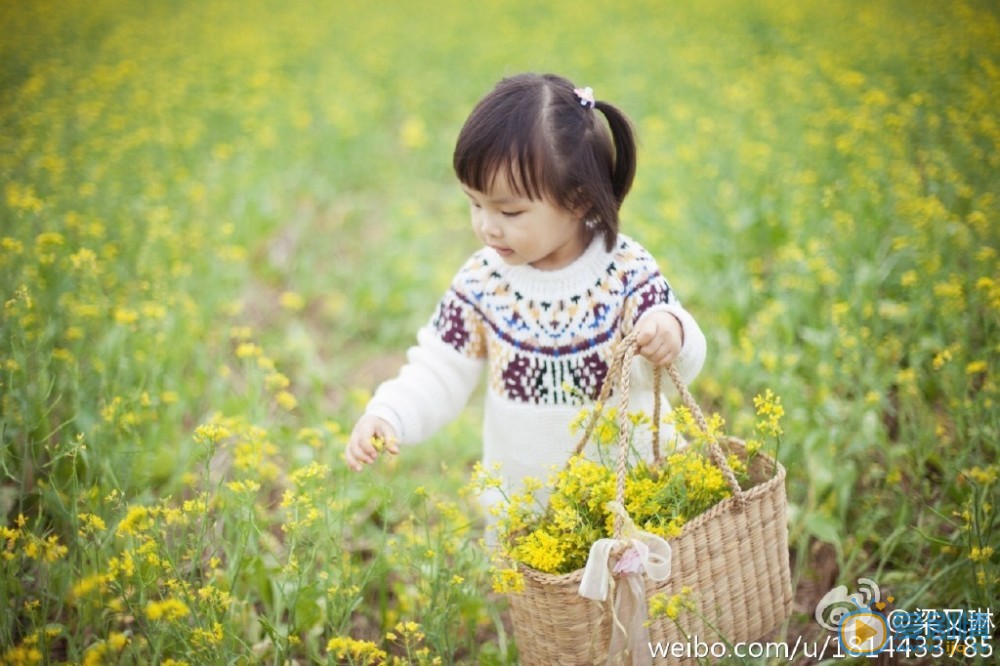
366, 235, 705, 503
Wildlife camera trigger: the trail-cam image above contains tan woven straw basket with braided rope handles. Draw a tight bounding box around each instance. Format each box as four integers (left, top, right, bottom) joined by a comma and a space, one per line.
509, 336, 792, 666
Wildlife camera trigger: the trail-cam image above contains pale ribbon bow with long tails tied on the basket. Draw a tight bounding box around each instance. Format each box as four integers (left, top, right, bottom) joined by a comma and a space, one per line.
579, 501, 671, 665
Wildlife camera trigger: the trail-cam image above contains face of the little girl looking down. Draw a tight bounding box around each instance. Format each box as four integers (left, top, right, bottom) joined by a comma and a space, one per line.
462, 178, 587, 271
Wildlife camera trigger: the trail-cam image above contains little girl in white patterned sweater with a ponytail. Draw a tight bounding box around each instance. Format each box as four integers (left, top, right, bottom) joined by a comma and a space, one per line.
345, 74, 705, 504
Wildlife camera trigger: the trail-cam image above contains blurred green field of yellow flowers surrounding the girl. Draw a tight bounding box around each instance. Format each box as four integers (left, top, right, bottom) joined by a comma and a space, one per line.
0, 0, 1000, 664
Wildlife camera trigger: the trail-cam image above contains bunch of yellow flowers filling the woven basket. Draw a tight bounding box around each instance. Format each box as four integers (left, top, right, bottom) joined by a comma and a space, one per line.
472, 391, 780, 592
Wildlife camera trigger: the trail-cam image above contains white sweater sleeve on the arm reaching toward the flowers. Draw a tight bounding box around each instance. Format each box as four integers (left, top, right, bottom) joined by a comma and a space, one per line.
365, 272, 486, 444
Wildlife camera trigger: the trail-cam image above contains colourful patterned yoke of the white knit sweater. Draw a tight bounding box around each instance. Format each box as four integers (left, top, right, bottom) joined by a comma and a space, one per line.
431, 236, 696, 406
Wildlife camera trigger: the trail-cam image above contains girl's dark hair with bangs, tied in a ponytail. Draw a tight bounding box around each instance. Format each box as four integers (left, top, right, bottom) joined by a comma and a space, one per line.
453, 74, 636, 251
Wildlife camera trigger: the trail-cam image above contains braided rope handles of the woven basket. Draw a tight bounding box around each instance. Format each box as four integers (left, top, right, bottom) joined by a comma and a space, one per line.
574, 331, 746, 539
